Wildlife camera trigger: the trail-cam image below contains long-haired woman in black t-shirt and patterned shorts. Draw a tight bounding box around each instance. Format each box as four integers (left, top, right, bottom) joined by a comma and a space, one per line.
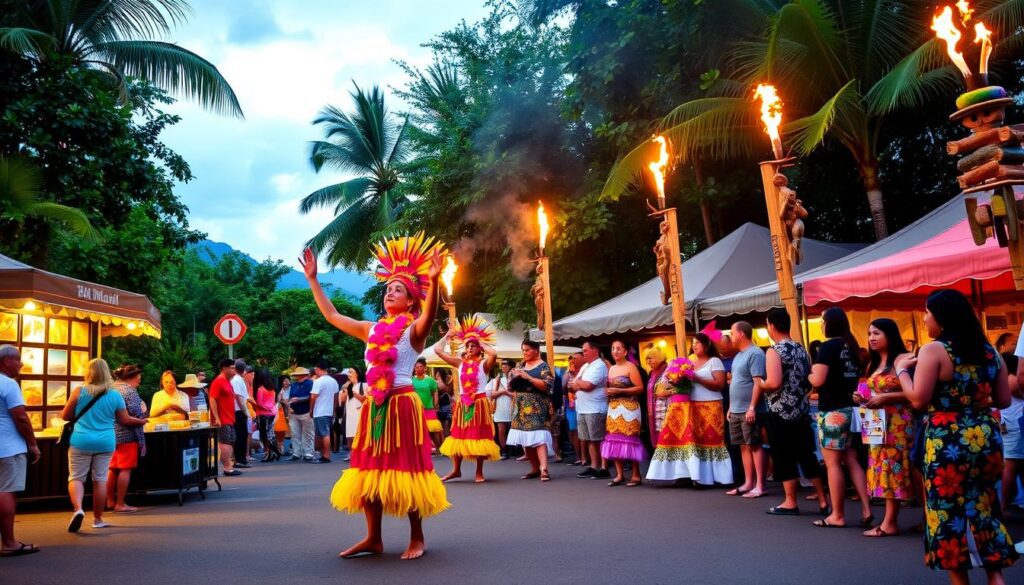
807, 306, 874, 528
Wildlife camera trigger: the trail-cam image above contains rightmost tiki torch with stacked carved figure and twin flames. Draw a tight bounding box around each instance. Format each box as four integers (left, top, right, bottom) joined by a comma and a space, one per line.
932, 0, 1024, 290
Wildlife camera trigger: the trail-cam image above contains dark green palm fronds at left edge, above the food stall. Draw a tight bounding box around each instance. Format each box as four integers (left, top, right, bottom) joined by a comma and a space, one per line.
0, 156, 100, 242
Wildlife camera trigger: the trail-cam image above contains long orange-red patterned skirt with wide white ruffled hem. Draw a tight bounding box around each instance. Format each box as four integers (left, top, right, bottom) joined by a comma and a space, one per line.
647, 395, 732, 486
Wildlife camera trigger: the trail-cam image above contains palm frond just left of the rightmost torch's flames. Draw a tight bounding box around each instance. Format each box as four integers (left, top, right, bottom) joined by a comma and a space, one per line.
865, 39, 959, 115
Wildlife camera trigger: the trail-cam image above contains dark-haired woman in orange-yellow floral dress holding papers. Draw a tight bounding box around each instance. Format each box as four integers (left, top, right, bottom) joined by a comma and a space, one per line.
854, 319, 913, 537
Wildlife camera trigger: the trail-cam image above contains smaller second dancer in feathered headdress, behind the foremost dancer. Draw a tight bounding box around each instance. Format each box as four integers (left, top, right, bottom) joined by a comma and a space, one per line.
434, 316, 501, 484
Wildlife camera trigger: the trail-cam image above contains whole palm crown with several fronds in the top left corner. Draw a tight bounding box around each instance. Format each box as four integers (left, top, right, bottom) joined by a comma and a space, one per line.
0, 0, 243, 118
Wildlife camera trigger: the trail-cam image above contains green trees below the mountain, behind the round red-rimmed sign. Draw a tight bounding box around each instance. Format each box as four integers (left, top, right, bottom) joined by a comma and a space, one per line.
104, 251, 362, 385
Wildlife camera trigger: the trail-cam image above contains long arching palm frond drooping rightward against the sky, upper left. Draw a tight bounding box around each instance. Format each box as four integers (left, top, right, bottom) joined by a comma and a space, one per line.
91, 41, 245, 118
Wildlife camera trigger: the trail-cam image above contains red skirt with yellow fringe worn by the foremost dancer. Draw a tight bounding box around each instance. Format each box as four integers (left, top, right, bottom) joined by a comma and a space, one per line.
331, 386, 451, 517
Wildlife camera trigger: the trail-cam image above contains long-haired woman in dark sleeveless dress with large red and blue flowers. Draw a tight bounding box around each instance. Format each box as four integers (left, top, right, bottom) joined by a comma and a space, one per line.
894, 290, 1018, 584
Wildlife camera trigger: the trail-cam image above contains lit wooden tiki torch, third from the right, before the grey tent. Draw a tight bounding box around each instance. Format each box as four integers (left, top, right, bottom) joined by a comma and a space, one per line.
647, 136, 686, 356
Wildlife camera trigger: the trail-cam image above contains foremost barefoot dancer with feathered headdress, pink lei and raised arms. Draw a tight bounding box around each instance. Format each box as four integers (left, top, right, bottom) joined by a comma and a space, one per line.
300, 234, 449, 558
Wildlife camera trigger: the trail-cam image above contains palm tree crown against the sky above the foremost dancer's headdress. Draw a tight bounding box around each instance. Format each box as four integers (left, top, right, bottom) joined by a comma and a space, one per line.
299, 84, 409, 269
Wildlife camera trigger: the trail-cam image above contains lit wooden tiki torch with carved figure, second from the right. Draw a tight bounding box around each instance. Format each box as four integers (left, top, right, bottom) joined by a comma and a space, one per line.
754, 84, 807, 342
